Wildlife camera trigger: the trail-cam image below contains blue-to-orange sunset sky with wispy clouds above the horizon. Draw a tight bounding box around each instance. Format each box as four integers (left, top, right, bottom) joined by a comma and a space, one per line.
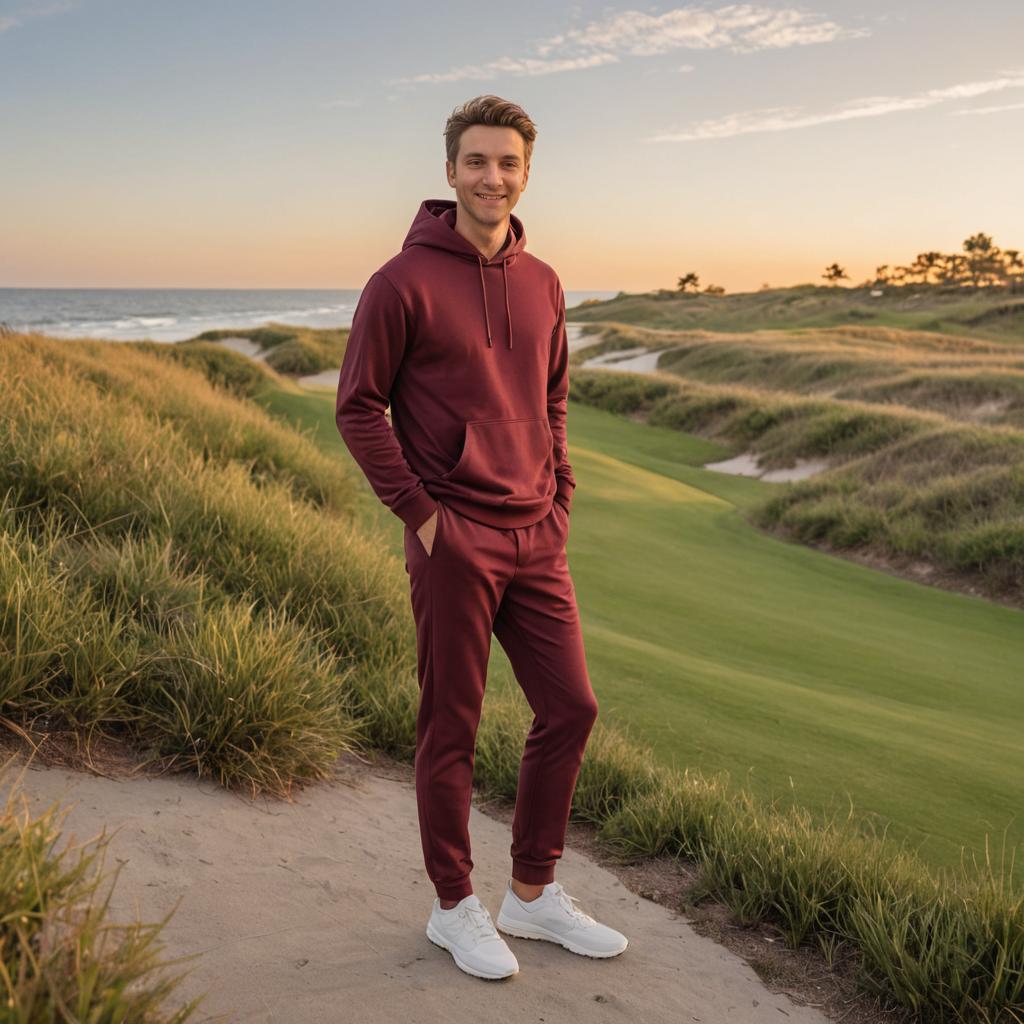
0, 0, 1024, 292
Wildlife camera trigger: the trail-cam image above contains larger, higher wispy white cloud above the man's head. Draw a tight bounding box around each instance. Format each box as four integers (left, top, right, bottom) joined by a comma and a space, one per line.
392, 3, 868, 84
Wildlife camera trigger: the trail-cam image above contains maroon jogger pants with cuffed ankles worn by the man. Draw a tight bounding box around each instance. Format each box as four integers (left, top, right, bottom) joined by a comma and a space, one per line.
404, 502, 598, 900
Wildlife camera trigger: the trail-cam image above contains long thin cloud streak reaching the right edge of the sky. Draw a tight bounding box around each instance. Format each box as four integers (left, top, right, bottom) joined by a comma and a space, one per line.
644, 71, 1024, 142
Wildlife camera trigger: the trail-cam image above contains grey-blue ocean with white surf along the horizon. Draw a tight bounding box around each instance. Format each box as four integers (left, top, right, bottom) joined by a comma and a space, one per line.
0, 288, 617, 342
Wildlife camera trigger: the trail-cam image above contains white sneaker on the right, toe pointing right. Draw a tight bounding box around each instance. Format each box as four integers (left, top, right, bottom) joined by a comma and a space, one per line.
498, 882, 629, 956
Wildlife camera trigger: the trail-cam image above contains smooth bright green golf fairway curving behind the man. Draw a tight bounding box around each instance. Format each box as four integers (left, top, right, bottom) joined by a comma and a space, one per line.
267, 380, 1024, 864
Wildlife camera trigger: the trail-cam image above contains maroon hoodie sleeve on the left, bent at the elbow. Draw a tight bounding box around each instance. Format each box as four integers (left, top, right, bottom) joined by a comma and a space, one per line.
335, 270, 437, 530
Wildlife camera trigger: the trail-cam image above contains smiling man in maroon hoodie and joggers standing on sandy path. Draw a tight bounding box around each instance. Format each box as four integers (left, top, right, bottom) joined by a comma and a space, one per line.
337, 95, 627, 978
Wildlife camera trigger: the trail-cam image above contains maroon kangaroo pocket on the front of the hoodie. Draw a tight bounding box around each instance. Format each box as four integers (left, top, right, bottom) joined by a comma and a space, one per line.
440, 417, 555, 508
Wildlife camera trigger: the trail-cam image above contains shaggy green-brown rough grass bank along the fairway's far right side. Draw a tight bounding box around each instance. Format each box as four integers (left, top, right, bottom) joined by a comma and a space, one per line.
570, 354, 1024, 604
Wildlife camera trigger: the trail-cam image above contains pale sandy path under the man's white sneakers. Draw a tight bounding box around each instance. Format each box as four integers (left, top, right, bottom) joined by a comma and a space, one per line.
2, 756, 827, 1024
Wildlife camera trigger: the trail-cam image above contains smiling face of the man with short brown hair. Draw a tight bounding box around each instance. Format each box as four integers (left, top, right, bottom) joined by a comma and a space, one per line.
444, 125, 529, 226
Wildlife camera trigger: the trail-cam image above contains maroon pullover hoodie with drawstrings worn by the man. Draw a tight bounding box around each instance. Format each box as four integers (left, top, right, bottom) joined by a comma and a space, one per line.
335, 199, 575, 530
